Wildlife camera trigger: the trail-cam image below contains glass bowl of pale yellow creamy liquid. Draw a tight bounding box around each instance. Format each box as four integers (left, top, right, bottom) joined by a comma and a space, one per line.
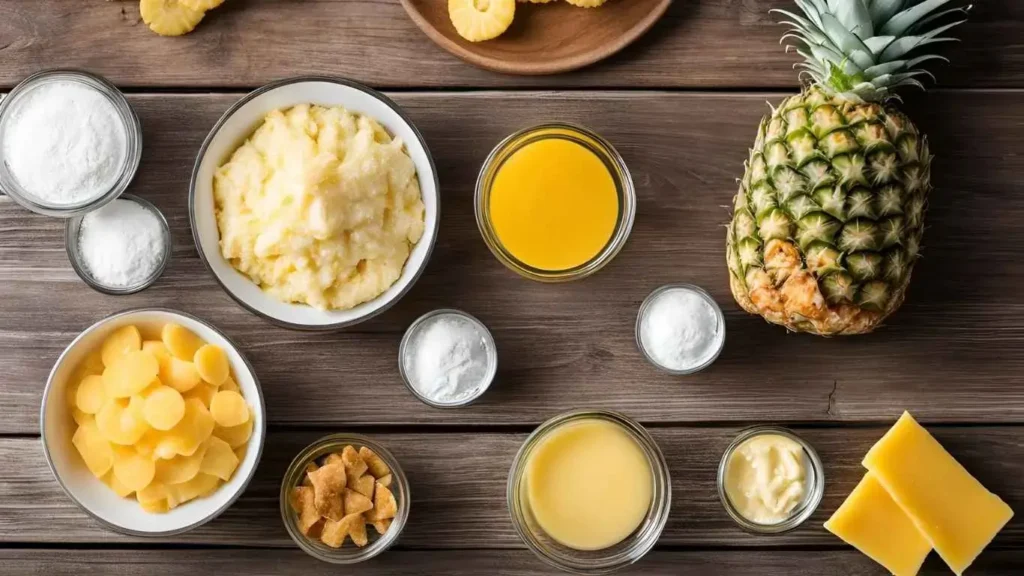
506, 410, 672, 574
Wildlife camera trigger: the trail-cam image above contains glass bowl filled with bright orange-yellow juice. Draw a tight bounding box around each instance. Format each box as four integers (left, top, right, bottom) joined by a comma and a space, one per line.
475, 123, 636, 282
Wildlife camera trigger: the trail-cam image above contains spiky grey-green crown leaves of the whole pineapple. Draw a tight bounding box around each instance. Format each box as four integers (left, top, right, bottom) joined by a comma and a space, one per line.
772, 0, 971, 101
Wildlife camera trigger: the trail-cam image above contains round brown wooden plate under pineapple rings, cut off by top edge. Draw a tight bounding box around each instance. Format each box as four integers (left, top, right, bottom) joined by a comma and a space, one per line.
401, 0, 672, 75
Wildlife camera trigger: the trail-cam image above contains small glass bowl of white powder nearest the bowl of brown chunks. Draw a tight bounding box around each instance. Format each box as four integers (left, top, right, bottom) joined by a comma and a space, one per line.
398, 308, 498, 408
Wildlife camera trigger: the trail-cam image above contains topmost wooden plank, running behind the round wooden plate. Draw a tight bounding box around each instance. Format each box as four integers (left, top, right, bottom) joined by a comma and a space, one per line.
0, 0, 1024, 88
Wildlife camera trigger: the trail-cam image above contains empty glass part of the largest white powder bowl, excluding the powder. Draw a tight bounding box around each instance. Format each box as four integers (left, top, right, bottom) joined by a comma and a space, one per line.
0, 69, 142, 218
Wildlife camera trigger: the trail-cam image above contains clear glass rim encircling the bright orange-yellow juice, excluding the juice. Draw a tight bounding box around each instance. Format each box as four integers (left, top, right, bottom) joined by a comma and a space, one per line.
473, 122, 637, 283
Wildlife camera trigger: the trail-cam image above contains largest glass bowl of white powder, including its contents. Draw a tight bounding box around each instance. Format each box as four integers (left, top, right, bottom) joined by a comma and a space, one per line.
0, 70, 142, 217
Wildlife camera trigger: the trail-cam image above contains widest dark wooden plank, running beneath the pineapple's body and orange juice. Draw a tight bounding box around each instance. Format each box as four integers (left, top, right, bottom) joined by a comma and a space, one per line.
0, 91, 1024, 434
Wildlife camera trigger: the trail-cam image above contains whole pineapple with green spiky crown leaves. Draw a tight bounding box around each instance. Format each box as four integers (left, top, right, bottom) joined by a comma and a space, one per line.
726, 0, 970, 335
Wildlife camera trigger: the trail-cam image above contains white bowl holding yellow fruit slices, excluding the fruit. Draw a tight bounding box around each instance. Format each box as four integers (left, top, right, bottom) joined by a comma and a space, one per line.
39, 308, 266, 536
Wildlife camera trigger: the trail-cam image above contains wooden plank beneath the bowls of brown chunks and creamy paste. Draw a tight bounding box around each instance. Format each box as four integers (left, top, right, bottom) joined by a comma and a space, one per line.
0, 426, 1024, 550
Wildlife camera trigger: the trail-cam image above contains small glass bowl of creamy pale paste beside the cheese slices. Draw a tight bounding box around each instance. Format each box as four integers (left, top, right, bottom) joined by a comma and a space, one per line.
718, 425, 825, 534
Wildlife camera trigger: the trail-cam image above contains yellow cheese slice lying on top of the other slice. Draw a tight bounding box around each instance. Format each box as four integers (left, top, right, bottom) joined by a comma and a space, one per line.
863, 412, 1014, 574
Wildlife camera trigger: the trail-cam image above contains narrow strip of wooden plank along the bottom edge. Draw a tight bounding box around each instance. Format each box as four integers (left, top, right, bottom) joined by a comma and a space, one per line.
0, 549, 1024, 576
